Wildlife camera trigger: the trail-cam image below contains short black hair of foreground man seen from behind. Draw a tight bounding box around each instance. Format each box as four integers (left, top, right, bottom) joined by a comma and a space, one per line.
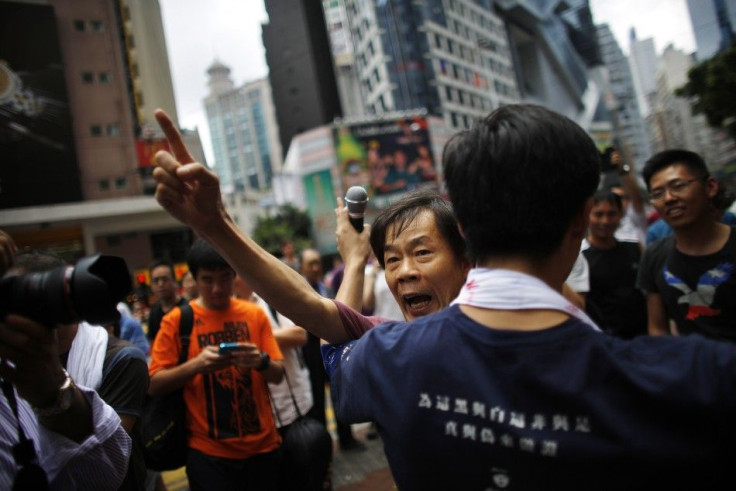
443, 104, 600, 261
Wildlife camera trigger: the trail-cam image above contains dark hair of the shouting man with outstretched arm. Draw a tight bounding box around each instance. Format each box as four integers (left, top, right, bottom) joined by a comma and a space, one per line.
370, 189, 465, 268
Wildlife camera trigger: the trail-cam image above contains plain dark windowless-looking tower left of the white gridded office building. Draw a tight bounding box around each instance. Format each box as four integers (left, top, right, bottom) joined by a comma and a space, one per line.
263, 0, 342, 158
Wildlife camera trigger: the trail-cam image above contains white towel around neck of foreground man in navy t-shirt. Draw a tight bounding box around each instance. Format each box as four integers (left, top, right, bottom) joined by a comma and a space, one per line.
452, 268, 600, 331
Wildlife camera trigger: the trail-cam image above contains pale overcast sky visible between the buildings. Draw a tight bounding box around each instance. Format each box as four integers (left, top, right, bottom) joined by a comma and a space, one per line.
159, 0, 695, 165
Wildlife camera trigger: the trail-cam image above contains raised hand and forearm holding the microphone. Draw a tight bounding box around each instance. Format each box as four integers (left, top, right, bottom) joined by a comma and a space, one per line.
335, 198, 371, 311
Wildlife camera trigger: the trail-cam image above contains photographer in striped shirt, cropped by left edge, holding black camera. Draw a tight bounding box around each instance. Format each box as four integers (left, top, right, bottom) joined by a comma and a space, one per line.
0, 231, 131, 490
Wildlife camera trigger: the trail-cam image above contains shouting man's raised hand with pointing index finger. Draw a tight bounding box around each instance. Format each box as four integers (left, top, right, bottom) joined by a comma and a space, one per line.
153, 109, 230, 236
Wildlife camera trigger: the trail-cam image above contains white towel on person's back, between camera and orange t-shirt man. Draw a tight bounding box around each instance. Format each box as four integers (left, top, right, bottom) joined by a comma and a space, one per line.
66, 322, 108, 390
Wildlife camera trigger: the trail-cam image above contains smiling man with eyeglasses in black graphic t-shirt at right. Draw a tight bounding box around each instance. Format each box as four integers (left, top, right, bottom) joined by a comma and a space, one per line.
637, 150, 736, 341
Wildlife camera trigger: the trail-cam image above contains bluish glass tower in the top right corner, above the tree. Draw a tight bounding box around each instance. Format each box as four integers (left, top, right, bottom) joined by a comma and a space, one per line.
687, 0, 736, 62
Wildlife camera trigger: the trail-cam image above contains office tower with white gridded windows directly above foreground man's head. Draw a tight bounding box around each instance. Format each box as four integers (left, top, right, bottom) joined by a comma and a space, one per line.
346, 0, 519, 129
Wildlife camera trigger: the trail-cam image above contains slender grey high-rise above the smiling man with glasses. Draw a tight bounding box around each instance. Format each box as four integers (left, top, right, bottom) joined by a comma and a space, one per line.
597, 24, 651, 171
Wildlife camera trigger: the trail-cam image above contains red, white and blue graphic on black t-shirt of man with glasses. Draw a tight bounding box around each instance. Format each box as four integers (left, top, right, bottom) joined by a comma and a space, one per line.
664, 263, 733, 320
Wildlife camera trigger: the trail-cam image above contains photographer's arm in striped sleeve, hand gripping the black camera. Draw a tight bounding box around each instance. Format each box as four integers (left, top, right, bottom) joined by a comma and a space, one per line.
0, 315, 132, 489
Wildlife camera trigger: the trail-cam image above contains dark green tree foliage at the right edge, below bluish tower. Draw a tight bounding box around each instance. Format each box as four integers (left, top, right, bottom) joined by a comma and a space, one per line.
675, 42, 736, 138
